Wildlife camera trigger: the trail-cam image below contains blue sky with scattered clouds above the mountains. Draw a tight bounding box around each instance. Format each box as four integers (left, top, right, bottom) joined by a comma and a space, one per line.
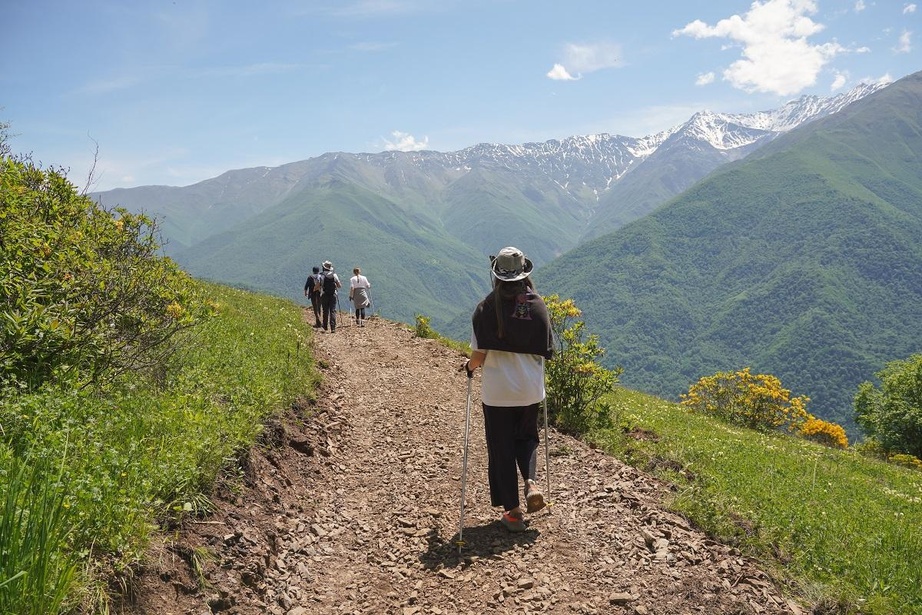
0, 0, 922, 190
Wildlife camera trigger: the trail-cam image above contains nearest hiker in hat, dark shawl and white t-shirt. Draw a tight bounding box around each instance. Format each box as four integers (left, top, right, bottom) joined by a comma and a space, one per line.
462, 247, 554, 532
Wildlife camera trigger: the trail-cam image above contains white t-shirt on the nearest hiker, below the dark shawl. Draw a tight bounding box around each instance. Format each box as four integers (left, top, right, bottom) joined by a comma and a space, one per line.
471, 333, 545, 406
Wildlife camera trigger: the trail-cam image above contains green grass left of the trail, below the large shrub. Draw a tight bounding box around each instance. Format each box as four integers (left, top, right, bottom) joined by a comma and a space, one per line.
0, 285, 319, 613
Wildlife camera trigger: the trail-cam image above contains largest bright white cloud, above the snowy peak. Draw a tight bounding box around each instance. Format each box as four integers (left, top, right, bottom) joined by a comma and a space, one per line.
672, 0, 848, 96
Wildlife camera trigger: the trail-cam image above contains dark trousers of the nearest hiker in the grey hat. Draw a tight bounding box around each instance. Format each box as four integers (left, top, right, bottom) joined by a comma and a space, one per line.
483, 404, 540, 510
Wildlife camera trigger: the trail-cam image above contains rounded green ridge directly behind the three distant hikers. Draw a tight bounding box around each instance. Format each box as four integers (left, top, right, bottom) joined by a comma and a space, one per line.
177, 180, 486, 332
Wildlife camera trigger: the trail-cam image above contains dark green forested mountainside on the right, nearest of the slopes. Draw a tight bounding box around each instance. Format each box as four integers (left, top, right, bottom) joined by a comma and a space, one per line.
538, 74, 922, 434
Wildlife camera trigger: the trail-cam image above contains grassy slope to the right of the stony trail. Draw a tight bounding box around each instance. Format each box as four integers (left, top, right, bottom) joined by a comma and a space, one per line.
593, 389, 922, 614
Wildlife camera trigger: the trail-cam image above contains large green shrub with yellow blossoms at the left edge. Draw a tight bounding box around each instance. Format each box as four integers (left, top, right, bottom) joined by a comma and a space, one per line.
0, 157, 204, 390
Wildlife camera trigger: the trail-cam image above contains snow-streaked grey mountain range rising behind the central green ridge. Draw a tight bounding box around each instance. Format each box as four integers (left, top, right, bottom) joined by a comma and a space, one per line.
97, 77, 884, 262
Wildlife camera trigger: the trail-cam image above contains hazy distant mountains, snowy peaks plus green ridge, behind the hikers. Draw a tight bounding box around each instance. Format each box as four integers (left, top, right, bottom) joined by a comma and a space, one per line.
93, 84, 882, 335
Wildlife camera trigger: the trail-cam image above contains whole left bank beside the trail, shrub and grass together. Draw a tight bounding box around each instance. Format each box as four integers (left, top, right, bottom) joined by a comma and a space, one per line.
0, 148, 316, 615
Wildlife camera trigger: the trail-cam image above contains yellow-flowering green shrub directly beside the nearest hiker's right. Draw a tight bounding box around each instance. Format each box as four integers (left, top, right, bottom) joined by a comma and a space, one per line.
545, 295, 622, 435
